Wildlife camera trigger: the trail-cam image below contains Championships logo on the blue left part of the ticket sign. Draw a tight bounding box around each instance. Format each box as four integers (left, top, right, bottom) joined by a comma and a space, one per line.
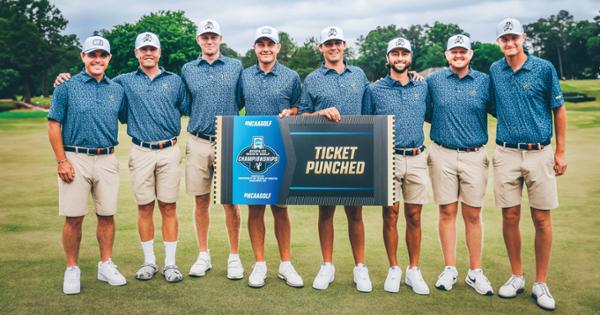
237, 136, 279, 174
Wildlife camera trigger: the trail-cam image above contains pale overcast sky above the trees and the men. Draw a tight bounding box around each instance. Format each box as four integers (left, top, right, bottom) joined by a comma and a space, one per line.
51, 0, 600, 53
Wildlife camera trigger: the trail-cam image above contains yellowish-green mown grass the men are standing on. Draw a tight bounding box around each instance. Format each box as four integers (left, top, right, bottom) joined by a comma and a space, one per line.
0, 80, 600, 314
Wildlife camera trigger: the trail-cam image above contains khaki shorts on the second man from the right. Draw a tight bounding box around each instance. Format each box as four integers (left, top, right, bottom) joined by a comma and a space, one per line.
427, 142, 489, 207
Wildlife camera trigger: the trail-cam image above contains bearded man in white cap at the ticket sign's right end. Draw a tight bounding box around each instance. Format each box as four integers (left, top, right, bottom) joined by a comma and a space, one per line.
365, 37, 429, 294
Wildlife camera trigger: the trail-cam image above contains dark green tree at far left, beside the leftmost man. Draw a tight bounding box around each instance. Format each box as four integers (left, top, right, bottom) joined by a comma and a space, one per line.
0, 0, 77, 102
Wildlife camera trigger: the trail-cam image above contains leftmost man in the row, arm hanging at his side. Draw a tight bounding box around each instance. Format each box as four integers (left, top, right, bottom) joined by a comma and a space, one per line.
48, 36, 127, 294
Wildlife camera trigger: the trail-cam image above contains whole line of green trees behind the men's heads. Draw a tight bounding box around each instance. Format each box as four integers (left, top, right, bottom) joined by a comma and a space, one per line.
0, 0, 600, 102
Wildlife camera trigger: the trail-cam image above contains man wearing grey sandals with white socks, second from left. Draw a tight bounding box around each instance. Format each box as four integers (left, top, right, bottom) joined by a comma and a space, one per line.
56, 32, 189, 282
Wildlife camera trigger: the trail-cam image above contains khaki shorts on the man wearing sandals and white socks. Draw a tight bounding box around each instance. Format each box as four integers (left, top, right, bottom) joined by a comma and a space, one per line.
129, 144, 181, 205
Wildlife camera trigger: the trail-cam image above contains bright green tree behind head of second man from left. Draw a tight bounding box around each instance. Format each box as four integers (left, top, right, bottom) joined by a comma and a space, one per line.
100, 11, 199, 76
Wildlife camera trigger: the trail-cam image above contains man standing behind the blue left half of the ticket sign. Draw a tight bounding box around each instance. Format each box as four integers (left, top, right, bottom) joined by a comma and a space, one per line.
241, 26, 304, 288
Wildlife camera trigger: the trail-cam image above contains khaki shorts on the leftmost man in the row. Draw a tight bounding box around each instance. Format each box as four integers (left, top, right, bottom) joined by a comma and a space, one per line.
58, 152, 119, 217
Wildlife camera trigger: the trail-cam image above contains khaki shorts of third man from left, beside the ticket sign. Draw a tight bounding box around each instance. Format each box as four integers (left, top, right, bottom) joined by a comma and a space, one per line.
185, 135, 215, 196
